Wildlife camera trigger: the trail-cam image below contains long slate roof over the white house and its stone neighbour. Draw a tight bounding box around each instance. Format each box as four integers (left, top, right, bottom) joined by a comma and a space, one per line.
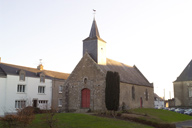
0, 63, 70, 79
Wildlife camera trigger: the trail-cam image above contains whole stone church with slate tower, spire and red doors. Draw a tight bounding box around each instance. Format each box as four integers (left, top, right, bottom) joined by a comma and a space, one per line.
63, 19, 154, 112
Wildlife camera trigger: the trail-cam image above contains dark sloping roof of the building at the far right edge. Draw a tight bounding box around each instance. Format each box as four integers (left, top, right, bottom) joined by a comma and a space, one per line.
175, 60, 192, 82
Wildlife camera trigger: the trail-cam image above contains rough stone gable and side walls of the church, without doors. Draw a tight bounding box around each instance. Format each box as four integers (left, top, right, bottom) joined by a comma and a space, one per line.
63, 53, 154, 111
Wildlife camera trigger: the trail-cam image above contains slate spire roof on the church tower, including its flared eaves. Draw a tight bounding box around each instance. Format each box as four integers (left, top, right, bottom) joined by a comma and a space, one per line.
83, 19, 105, 42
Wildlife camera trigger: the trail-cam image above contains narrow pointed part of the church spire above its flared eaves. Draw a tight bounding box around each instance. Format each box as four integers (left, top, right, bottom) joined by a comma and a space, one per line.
89, 18, 100, 38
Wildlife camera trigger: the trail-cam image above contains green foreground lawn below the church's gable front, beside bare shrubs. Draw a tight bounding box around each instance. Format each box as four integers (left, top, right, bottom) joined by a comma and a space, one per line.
29, 113, 152, 128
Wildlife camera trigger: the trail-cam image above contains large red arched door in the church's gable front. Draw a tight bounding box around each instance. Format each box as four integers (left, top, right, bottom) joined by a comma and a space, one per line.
81, 88, 90, 108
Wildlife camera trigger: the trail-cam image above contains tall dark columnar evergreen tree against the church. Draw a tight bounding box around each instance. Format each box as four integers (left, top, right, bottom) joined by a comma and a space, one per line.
105, 71, 120, 111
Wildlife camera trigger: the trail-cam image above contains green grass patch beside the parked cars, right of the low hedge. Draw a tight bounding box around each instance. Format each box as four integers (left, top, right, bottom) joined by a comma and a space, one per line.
129, 108, 192, 123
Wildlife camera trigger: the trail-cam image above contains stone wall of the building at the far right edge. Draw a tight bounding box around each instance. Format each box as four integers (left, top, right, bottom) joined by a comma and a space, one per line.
173, 81, 192, 107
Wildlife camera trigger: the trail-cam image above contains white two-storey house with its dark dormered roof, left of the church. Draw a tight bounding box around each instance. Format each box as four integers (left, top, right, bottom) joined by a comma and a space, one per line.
0, 62, 68, 116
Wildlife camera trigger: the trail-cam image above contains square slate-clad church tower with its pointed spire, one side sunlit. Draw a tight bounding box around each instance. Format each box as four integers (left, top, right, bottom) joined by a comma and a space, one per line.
83, 18, 106, 65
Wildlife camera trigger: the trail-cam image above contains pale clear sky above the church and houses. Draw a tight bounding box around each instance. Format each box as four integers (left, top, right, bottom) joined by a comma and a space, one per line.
0, 0, 192, 99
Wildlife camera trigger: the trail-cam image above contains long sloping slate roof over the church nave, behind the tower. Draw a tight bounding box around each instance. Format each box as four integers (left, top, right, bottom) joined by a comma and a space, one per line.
99, 58, 153, 87
